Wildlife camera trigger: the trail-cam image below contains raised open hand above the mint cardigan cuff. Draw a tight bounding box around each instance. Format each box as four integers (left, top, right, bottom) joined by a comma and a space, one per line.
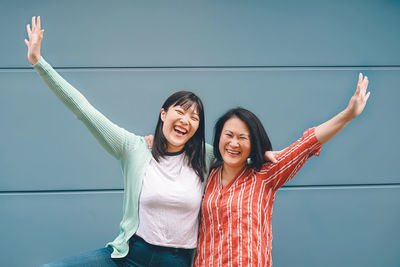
25, 16, 44, 65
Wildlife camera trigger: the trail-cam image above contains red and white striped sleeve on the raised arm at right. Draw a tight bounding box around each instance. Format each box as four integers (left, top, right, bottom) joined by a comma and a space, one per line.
259, 128, 322, 190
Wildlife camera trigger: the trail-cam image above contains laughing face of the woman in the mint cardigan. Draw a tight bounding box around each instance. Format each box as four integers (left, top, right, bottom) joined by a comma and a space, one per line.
161, 104, 200, 152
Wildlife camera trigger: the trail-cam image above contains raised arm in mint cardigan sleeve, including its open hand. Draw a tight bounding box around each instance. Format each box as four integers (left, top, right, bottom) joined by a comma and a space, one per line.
25, 17, 138, 159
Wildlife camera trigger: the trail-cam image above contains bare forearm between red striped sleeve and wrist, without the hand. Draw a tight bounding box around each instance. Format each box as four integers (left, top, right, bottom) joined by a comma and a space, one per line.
315, 109, 353, 144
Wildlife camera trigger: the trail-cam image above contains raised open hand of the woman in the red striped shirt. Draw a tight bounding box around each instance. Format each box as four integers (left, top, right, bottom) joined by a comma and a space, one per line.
346, 73, 371, 119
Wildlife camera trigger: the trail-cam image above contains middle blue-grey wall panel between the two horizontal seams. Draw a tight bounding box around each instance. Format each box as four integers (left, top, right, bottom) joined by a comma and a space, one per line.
0, 69, 400, 190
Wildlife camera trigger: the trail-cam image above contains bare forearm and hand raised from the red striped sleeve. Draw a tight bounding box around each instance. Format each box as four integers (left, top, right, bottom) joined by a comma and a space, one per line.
315, 73, 370, 144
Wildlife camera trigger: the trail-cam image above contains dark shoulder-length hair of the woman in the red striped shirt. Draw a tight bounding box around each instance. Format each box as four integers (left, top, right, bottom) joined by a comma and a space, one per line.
211, 107, 272, 173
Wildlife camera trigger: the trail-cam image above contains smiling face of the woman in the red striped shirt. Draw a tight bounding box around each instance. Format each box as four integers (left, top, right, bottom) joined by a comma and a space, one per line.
219, 117, 251, 172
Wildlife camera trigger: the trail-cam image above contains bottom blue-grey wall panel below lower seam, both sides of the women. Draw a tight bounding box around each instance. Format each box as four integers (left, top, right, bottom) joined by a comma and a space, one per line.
0, 186, 400, 267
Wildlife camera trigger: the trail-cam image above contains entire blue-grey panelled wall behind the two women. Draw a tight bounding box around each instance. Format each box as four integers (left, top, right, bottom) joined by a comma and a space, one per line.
0, 0, 400, 267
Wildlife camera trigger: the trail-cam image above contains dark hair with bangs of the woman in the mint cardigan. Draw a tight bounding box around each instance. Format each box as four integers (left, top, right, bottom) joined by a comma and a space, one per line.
151, 91, 206, 181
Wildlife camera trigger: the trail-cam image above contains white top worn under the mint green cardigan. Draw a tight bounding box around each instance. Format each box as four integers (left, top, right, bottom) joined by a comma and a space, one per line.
136, 151, 203, 248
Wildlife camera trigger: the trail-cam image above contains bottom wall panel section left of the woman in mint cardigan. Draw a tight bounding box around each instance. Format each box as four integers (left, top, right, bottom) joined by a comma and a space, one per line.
0, 191, 123, 267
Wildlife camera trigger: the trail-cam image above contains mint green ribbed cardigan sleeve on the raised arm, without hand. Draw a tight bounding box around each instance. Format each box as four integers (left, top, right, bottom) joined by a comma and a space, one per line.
33, 57, 138, 159
